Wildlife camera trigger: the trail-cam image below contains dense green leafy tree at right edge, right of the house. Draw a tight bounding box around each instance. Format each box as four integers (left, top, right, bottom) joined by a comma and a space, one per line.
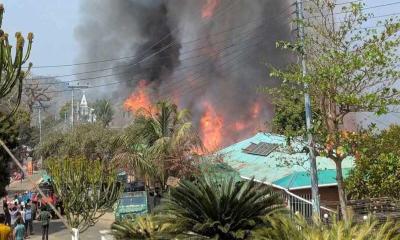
346, 126, 400, 199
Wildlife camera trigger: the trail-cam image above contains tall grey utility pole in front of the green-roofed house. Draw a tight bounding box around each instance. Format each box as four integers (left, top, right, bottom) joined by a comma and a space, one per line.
296, 0, 320, 217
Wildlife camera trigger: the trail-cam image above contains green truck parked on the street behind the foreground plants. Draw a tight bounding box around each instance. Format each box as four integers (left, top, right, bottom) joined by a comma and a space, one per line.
114, 191, 148, 221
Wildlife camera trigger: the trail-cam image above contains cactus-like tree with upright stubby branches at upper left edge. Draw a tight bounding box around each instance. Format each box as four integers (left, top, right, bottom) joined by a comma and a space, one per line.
0, 4, 33, 113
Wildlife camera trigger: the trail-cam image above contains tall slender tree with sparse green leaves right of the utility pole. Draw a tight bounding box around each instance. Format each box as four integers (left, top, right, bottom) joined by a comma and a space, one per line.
268, 0, 400, 218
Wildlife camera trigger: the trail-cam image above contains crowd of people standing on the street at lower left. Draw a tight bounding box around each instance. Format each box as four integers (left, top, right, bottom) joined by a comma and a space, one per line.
0, 192, 52, 240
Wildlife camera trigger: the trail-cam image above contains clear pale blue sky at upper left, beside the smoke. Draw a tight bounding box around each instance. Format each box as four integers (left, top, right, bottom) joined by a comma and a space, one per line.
1, 0, 79, 75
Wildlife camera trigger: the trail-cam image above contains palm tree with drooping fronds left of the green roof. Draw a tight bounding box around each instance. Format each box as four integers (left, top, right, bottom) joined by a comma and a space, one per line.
116, 101, 202, 186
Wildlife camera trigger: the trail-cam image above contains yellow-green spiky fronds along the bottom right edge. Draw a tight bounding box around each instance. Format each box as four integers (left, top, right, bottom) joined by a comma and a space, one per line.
253, 215, 400, 240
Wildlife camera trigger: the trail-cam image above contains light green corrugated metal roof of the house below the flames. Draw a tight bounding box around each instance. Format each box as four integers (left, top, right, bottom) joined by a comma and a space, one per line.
218, 133, 353, 187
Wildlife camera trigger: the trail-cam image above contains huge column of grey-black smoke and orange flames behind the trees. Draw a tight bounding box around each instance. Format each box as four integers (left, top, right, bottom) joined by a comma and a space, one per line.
77, 0, 291, 150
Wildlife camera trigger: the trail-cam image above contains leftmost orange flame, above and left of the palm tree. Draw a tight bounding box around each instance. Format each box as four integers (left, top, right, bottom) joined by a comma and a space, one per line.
124, 80, 153, 112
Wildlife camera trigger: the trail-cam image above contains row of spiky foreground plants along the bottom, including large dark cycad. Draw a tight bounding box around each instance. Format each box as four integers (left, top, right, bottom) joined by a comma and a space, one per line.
112, 174, 400, 240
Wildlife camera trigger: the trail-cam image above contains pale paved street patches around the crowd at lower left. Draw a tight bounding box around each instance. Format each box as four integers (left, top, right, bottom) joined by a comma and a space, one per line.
1, 174, 114, 240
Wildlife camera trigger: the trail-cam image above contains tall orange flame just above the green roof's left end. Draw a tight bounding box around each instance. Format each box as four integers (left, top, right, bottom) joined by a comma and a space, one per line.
200, 102, 223, 150
